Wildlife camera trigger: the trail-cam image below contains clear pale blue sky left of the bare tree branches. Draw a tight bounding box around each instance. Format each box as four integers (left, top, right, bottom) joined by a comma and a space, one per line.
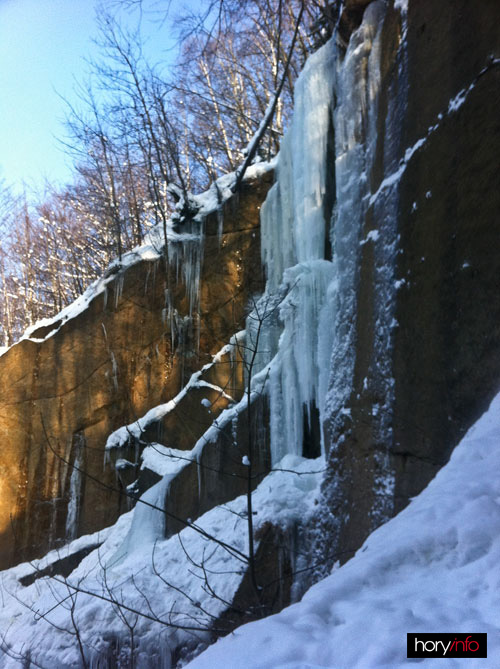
0, 0, 191, 190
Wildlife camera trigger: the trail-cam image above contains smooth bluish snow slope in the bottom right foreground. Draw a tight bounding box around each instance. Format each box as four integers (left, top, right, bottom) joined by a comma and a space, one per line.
189, 394, 500, 669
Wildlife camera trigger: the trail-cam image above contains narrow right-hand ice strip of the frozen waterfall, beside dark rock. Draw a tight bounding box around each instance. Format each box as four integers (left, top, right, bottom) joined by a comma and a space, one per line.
326, 3, 390, 440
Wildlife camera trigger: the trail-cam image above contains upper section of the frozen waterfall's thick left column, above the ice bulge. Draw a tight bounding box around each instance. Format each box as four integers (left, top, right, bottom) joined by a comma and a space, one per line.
261, 41, 335, 291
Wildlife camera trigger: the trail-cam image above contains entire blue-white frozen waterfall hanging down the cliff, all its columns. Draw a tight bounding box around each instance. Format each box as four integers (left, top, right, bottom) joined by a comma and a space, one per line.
256, 1, 404, 474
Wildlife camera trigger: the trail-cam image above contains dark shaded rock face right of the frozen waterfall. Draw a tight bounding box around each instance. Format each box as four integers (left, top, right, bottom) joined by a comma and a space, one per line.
316, 0, 500, 561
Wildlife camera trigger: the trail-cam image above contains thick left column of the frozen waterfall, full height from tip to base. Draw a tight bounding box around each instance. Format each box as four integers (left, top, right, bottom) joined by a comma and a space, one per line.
256, 40, 336, 462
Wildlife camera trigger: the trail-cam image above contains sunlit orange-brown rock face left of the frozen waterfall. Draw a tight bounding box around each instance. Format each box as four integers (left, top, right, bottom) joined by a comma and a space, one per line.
0, 172, 272, 568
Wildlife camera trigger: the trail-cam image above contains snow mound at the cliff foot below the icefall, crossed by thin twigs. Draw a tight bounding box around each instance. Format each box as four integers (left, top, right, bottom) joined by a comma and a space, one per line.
0, 456, 324, 669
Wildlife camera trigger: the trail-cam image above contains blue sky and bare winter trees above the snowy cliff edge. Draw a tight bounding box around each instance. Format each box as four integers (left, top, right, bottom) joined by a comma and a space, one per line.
0, 0, 306, 346
